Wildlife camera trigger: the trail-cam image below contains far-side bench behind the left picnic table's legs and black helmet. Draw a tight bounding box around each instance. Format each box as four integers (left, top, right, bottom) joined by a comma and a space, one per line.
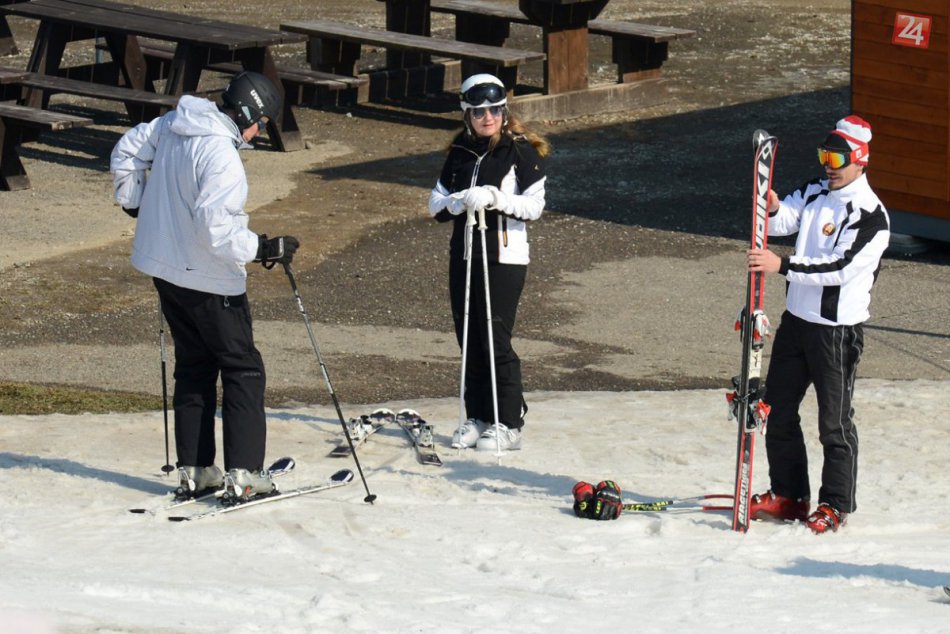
96, 42, 366, 106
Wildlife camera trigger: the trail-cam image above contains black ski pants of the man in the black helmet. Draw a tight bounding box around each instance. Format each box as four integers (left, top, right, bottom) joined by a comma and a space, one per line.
154, 278, 267, 470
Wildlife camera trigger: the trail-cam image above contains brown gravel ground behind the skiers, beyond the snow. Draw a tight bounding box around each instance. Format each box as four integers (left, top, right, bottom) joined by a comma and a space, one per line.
0, 0, 950, 406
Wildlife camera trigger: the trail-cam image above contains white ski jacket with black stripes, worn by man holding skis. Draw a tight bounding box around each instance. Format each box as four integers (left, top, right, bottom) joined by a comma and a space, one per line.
769, 174, 890, 326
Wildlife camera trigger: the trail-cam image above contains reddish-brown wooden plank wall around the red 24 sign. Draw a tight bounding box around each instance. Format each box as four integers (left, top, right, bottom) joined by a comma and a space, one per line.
851, 0, 950, 219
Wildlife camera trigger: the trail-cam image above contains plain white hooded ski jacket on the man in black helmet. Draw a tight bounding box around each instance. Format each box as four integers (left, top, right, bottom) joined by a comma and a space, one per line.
110, 95, 259, 295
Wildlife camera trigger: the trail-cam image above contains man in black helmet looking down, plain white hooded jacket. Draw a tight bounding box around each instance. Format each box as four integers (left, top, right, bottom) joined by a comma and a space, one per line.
110, 72, 299, 497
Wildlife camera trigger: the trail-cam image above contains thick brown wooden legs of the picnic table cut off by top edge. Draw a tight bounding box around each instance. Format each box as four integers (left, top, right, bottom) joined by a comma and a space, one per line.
379, 0, 608, 94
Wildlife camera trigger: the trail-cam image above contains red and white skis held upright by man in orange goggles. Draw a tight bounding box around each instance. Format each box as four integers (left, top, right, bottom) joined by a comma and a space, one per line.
726, 130, 778, 533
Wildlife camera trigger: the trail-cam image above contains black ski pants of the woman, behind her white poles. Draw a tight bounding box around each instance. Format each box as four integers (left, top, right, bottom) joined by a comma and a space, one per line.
449, 254, 528, 429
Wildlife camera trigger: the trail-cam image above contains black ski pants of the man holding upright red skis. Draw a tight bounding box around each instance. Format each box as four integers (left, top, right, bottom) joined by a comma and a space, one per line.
765, 311, 864, 513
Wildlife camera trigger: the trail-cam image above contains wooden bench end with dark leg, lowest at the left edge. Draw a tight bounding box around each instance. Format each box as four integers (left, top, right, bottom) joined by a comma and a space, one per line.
0, 103, 92, 191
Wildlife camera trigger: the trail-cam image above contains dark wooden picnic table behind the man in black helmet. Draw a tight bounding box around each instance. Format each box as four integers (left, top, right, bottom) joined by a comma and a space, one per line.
0, 0, 307, 151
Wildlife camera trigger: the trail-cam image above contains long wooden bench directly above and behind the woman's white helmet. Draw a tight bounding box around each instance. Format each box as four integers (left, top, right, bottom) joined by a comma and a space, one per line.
280, 20, 545, 91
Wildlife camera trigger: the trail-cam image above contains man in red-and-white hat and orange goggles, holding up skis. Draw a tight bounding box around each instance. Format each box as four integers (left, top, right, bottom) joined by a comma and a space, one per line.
747, 115, 890, 533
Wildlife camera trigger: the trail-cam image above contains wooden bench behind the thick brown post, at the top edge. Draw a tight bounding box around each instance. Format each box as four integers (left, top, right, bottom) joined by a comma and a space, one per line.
431, 0, 696, 83
